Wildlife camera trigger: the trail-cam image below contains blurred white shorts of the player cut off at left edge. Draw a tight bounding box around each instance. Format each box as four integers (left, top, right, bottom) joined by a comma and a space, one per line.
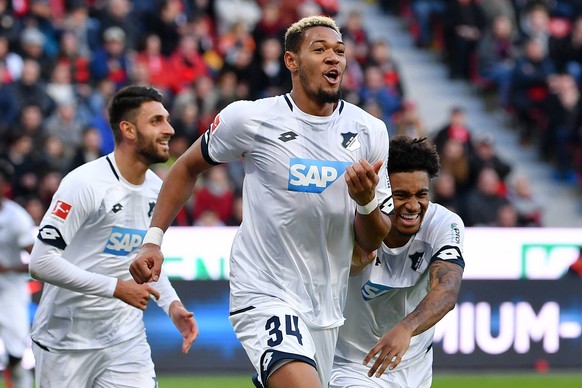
0, 290, 30, 358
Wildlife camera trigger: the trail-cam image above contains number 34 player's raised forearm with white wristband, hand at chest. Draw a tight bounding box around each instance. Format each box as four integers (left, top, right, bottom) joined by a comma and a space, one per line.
345, 159, 391, 252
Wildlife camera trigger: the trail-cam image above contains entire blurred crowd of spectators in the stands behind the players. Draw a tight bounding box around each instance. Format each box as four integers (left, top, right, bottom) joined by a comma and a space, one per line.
0, 0, 556, 227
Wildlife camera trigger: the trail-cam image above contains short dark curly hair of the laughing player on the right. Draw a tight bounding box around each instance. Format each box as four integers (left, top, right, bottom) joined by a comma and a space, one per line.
388, 135, 441, 178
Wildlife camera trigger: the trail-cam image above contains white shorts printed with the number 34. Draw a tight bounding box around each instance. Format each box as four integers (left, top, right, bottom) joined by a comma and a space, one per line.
229, 303, 339, 387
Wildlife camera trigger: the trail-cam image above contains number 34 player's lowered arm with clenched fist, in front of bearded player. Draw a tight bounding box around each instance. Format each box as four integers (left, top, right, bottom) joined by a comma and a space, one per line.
130, 138, 212, 284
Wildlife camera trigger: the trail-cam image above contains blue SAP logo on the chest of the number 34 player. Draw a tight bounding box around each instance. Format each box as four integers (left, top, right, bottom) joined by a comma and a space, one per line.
287, 158, 352, 193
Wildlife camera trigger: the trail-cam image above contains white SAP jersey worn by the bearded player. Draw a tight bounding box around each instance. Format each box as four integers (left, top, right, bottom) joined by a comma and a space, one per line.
31, 154, 178, 350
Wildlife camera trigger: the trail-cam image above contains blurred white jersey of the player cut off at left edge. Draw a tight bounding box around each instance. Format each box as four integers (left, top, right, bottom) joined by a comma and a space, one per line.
0, 198, 34, 295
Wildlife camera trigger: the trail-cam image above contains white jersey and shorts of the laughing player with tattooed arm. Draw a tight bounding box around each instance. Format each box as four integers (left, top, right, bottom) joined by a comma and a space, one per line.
330, 202, 465, 388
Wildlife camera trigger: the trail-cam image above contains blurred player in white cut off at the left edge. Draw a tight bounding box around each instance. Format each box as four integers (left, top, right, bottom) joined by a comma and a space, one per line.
0, 160, 34, 388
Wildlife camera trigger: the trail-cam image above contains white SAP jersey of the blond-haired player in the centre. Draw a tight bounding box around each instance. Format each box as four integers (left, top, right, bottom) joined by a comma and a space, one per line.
202, 94, 393, 328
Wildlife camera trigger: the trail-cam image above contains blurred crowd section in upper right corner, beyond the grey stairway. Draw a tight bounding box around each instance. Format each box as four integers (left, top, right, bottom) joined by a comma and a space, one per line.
392, 0, 582, 187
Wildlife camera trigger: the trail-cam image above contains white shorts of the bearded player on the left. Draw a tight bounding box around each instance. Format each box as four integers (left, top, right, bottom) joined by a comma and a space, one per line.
32, 334, 158, 388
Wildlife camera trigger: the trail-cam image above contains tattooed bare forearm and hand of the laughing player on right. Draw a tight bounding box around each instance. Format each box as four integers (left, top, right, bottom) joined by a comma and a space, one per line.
364, 260, 463, 377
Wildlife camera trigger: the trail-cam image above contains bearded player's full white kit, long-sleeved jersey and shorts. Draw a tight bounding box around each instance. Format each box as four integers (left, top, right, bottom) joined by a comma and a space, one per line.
31, 153, 178, 387
